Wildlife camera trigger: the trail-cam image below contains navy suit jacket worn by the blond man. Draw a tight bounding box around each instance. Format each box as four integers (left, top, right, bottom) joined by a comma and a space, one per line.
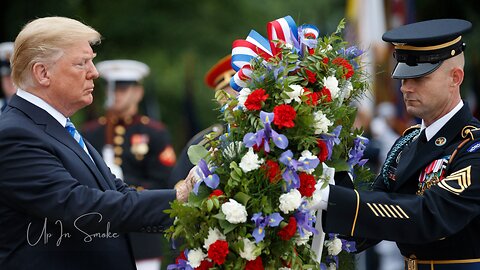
0, 96, 175, 270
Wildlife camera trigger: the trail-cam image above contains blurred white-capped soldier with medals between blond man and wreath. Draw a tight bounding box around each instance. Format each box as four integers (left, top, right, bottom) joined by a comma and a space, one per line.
83, 60, 176, 269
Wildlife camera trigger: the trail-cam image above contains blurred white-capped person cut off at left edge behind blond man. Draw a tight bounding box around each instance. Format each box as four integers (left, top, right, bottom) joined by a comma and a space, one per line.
0, 42, 17, 114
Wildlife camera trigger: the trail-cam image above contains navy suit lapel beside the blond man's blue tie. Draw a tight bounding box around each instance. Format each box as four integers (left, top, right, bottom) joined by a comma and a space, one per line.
9, 95, 110, 190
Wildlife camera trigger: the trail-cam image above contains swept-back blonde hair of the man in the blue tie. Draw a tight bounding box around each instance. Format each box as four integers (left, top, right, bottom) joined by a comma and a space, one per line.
11, 17, 101, 89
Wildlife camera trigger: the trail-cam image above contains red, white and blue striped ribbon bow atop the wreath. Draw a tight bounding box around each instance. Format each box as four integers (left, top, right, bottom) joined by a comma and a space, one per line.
230, 16, 319, 91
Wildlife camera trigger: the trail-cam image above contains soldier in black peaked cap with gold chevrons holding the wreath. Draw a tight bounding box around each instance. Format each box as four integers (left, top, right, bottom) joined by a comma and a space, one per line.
313, 19, 480, 270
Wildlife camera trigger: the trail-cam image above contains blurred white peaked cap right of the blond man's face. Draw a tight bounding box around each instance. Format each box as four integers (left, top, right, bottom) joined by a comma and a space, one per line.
95, 60, 150, 82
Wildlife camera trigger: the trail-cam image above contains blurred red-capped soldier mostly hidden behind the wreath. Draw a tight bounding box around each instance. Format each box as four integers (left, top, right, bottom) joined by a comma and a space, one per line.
169, 55, 232, 185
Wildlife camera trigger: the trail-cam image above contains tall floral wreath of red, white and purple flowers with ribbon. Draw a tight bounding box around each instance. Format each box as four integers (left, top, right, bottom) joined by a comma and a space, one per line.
166, 16, 371, 269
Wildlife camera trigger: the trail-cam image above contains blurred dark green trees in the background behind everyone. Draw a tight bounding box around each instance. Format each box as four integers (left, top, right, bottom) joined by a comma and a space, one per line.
0, 0, 480, 152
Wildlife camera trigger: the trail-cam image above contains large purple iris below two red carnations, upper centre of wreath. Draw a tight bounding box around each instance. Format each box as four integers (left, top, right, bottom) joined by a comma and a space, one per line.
243, 111, 288, 153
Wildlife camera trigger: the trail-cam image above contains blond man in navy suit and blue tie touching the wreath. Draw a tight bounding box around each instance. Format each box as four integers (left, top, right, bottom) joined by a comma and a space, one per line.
0, 17, 192, 270
